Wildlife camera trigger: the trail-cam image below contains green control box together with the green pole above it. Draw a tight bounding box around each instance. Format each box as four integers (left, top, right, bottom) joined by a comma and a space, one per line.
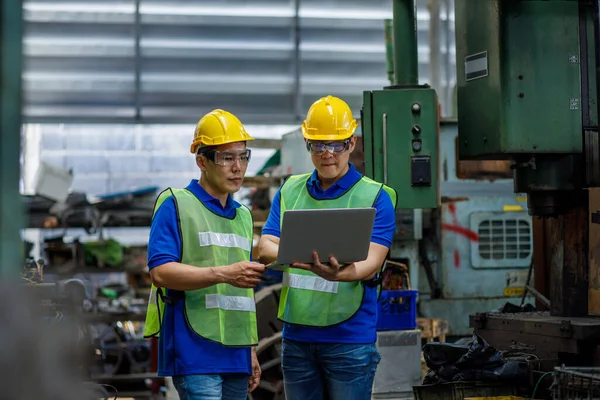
361, 1, 440, 209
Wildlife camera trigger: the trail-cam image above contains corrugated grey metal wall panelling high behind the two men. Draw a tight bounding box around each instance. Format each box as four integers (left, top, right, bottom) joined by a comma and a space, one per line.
23, 0, 454, 124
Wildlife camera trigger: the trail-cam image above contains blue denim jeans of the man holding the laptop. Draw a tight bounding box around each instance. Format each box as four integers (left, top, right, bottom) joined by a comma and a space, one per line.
281, 339, 381, 400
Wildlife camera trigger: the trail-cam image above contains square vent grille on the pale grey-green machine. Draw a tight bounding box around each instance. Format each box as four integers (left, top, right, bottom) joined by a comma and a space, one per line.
471, 212, 533, 268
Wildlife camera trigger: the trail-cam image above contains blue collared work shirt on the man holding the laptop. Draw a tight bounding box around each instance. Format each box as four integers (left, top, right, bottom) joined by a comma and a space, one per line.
262, 163, 396, 344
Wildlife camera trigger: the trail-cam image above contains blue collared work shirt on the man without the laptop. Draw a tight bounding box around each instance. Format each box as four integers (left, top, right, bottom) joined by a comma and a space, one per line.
148, 179, 252, 376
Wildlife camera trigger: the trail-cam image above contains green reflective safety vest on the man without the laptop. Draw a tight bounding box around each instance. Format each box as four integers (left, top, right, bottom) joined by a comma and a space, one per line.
144, 188, 258, 346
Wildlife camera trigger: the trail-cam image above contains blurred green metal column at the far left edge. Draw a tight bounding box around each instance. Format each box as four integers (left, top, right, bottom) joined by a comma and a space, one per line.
0, 0, 23, 277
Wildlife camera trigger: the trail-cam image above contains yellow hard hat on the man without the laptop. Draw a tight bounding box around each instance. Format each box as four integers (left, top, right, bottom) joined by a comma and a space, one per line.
190, 109, 254, 153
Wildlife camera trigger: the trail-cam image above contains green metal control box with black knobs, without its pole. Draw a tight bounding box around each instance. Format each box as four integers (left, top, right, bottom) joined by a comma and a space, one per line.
361, 85, 440, 209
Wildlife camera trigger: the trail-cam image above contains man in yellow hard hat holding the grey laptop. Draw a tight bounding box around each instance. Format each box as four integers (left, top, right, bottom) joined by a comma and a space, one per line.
259, 96, 396, 400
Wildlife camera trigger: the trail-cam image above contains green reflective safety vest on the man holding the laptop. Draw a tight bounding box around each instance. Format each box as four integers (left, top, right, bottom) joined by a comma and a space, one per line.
278, 174, 397, 327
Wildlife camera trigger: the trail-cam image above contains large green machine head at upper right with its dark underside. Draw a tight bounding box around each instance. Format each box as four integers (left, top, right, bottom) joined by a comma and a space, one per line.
455, 0, 600, 216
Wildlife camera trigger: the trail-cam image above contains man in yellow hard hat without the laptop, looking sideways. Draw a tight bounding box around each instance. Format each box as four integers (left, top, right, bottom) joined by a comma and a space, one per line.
144, 110, 265, 400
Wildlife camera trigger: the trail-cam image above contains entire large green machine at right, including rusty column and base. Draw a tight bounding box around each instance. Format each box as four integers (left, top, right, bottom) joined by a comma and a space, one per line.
455, 0, 600, 366
